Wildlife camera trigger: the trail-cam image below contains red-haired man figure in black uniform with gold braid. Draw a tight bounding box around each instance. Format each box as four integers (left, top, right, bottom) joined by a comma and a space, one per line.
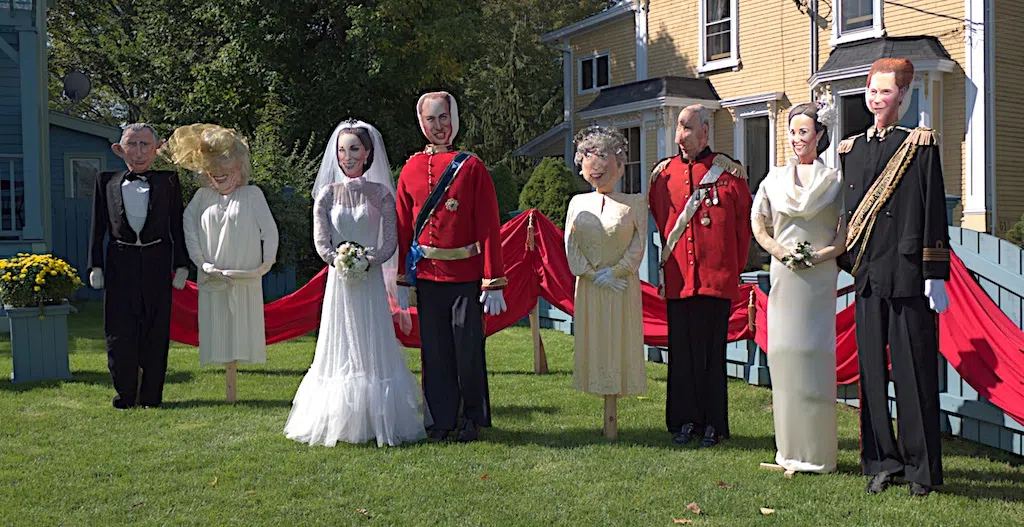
839, 58, 949, 496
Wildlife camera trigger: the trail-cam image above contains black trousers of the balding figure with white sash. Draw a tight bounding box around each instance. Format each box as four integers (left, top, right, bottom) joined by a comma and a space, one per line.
665, 296, 732, 437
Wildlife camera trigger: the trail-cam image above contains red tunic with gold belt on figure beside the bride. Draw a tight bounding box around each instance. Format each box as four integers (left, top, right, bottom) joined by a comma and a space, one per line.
395, 148, 507, 290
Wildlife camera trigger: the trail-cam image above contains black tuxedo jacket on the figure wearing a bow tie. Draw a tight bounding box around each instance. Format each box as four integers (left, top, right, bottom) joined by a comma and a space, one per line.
89, 170, 188, 279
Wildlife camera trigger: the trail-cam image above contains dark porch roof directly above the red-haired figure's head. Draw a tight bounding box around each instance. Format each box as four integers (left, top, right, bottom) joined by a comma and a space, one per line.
807, 36, 953, 87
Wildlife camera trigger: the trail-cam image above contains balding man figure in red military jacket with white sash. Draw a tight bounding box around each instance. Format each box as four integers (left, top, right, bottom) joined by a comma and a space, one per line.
649, 104, 753, 446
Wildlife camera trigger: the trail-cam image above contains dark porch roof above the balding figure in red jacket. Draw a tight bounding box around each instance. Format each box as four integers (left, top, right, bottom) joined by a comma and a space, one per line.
580, 77, 721, 119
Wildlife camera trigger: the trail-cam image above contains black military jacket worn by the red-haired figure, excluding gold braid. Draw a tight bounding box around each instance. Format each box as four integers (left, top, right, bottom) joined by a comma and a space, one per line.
839, 127, 949, 298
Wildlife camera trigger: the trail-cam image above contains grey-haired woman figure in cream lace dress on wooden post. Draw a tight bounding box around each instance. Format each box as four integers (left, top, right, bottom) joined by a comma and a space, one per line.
565, 127, 647, 439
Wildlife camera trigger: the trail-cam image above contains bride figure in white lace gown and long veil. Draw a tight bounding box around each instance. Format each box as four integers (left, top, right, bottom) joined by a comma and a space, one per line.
285, 121, 430, 446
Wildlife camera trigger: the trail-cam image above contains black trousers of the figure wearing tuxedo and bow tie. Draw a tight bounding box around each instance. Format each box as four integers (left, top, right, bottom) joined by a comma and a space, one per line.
103, 244, 171, 408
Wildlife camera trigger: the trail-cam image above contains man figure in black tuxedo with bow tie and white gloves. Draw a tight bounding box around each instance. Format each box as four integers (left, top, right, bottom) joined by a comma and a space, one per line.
89, 124, 188, 409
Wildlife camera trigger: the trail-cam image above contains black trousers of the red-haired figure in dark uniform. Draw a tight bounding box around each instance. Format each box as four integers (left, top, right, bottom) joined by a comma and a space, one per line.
855, 292, 942, 486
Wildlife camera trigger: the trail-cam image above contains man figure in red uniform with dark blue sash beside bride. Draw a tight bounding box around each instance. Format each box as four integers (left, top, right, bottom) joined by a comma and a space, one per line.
396, 92, 507, 442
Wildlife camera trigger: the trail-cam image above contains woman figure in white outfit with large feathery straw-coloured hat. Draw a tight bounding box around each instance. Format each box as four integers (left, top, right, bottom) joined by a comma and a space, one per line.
163, 124, 278, 400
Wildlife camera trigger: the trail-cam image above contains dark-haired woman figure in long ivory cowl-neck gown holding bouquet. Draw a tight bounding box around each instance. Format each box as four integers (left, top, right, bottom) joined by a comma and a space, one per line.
751, 103, 846, 473
